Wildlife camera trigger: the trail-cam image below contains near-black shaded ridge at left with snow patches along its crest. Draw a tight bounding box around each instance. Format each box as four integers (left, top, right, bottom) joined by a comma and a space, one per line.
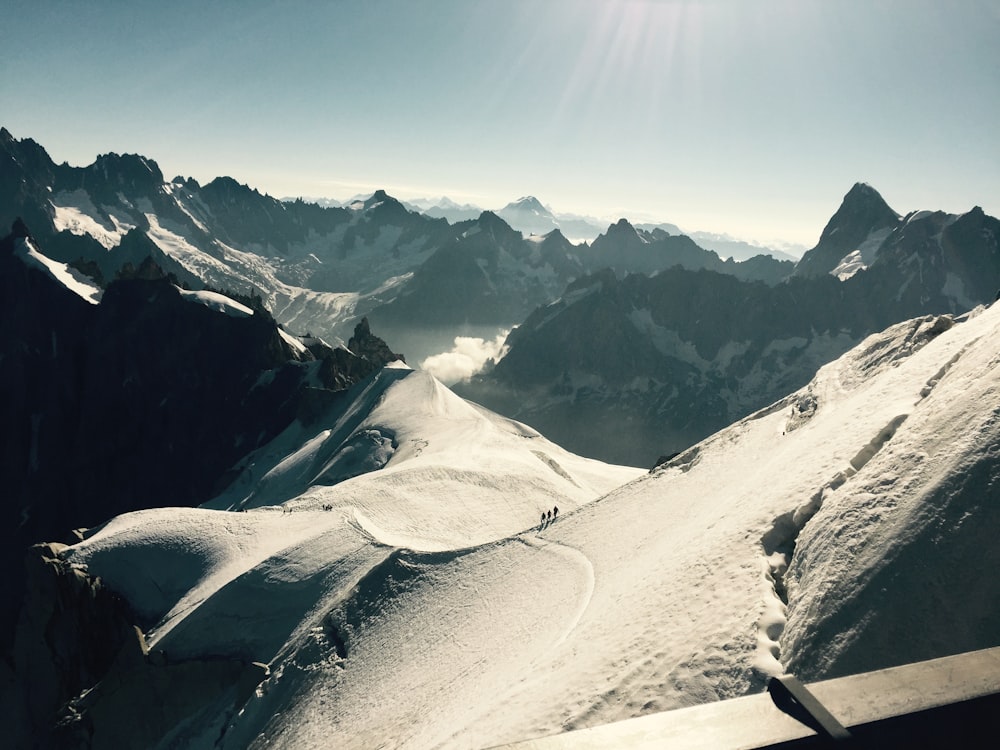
0, 222, 398, 651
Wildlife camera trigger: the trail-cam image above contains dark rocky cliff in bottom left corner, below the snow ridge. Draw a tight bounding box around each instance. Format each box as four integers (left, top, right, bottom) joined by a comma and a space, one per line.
0, 543, 268, 750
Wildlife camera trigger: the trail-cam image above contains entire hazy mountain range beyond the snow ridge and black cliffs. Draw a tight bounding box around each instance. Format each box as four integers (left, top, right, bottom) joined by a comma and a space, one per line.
0, 125, 1000, 465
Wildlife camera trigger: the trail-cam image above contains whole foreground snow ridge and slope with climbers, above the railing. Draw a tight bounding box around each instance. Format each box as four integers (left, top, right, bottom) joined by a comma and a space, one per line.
62, 308, 1000, 748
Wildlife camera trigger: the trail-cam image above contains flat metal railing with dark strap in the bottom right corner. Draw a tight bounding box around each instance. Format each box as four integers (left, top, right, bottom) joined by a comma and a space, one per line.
496, 647, 1000, 750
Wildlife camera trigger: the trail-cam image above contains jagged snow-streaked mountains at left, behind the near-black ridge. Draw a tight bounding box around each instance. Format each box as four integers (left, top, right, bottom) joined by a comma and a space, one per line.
0, 129, 453, 352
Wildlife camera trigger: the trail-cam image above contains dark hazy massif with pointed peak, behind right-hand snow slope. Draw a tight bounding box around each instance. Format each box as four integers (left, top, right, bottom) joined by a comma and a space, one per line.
456, 184, 1000, 466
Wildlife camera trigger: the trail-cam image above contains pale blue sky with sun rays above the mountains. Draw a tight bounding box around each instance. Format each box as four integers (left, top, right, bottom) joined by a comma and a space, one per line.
0, 0, 1000, 247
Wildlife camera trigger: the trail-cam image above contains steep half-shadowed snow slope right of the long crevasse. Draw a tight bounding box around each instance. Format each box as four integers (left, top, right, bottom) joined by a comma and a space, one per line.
786, 306, 1000, 678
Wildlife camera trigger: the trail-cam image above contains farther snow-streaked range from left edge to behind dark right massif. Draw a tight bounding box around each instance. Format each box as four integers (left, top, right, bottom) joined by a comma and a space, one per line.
0, 128, 792, 363
